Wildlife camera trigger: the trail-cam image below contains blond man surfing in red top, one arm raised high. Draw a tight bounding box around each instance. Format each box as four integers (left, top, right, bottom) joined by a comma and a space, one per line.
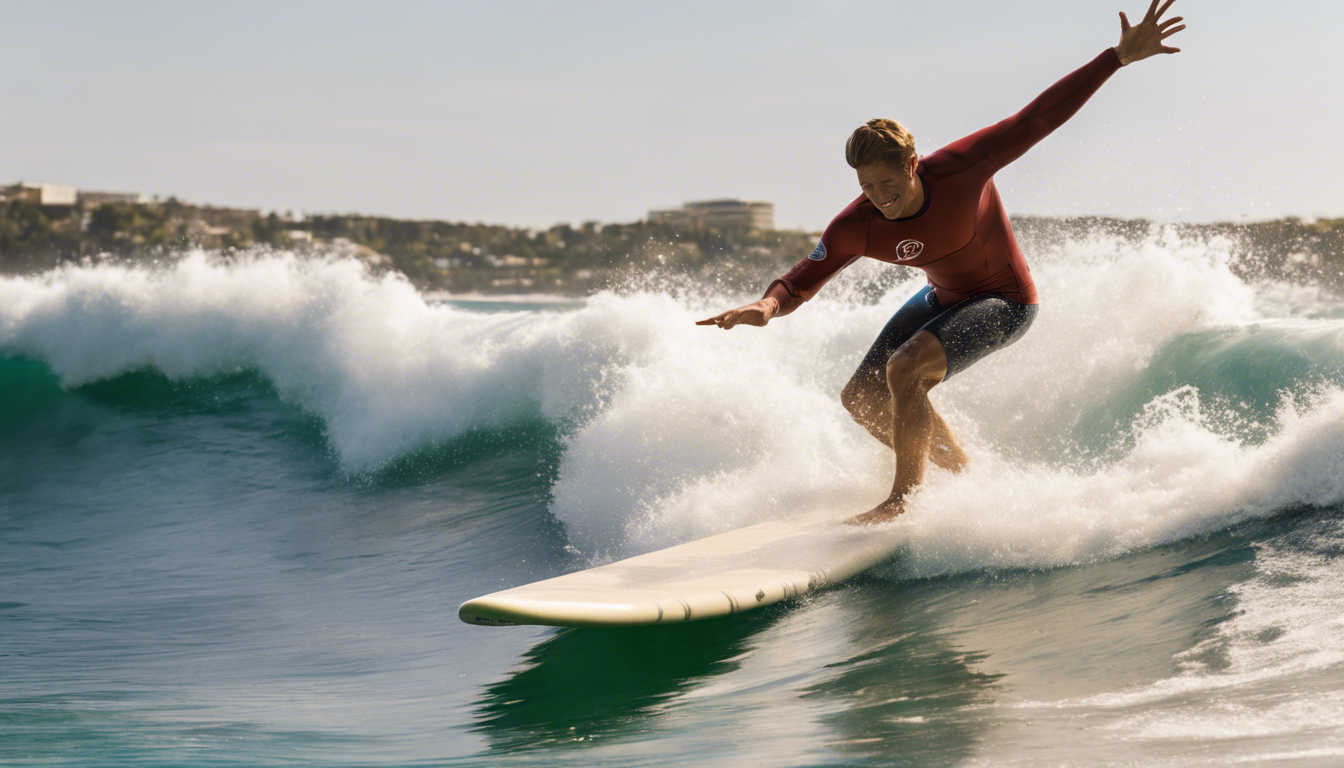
696, 0, 1185, 523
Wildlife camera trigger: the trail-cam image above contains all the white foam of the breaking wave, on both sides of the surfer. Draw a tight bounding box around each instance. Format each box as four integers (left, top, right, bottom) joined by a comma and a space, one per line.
0, 231, 1344, 576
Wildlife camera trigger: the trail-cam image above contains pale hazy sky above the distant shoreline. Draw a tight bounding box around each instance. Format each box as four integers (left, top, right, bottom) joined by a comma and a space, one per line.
0, 0, 1344, 231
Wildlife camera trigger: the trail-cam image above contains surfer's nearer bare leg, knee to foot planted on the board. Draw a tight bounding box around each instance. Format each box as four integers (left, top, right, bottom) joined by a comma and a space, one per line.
848, 331, 952, 523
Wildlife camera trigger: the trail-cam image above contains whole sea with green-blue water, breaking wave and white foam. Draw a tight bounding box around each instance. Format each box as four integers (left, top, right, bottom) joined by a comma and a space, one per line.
0, 229, 1344, 767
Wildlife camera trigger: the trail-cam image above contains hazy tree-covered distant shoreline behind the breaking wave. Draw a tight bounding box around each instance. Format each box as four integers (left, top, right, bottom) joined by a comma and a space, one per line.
0, 198, 1344, 304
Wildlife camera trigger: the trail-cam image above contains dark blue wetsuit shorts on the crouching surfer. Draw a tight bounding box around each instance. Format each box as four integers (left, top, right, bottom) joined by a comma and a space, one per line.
855, 285, 1039, 386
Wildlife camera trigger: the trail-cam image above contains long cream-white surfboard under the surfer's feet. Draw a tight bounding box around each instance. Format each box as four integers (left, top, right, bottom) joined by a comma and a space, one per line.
457, 512, 905, 627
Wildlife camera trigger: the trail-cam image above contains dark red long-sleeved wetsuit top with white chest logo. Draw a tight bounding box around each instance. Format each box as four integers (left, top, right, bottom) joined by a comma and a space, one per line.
765, 48, 1120, 315
